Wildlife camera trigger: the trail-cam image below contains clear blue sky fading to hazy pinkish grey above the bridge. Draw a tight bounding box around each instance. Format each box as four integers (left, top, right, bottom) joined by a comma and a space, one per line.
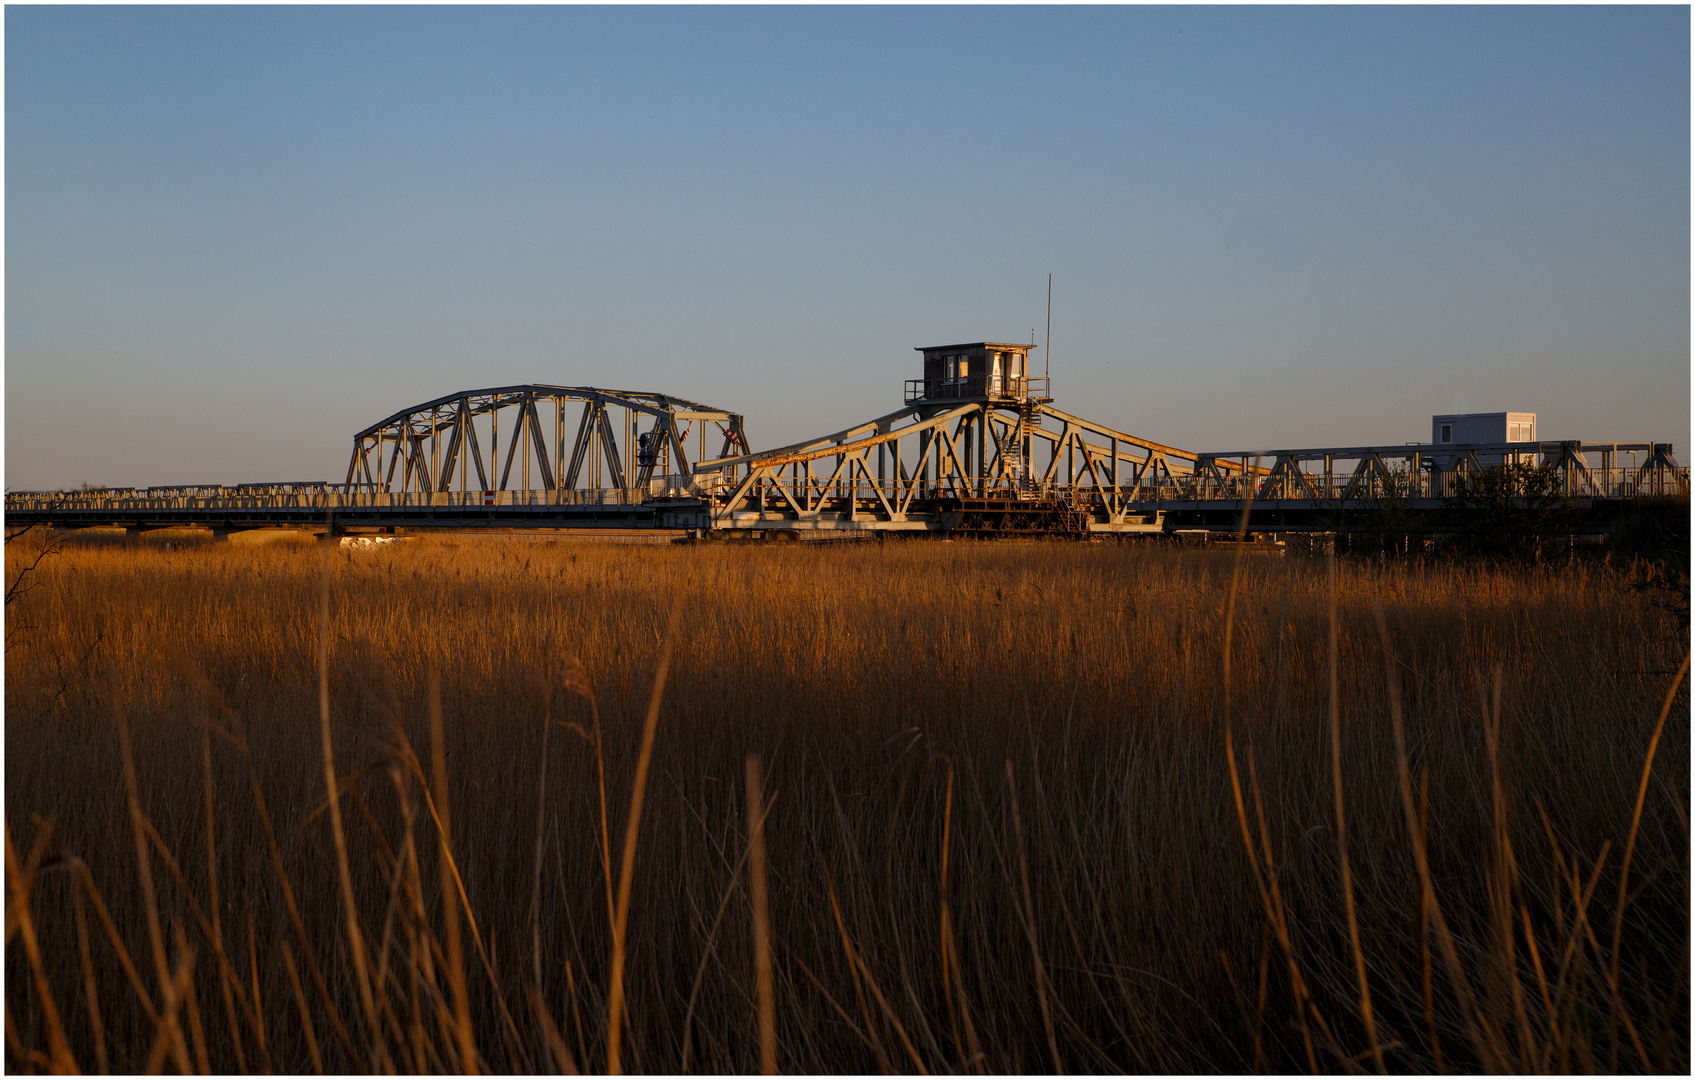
5, 7, 1692, 488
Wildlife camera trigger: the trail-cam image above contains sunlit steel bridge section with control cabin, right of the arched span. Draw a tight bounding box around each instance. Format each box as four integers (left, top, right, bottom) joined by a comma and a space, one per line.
678, 342, 1688, 536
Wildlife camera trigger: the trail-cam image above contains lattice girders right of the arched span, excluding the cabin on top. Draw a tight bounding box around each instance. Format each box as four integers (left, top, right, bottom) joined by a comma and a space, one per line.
697, 398, 1688, 529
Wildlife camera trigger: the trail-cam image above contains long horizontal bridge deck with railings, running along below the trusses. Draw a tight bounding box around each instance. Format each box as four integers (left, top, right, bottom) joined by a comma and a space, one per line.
5, 468, 1690, 532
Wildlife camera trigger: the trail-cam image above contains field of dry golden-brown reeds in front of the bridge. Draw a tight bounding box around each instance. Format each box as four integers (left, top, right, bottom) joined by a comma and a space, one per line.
5, 534, 1690, 1073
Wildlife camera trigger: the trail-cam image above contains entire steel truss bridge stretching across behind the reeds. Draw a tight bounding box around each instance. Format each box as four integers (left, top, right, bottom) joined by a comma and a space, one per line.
5, 380, 1690, 539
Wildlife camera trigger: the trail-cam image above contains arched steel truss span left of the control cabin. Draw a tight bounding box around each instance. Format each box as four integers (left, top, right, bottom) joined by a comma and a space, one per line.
347, 383, 749, 500
